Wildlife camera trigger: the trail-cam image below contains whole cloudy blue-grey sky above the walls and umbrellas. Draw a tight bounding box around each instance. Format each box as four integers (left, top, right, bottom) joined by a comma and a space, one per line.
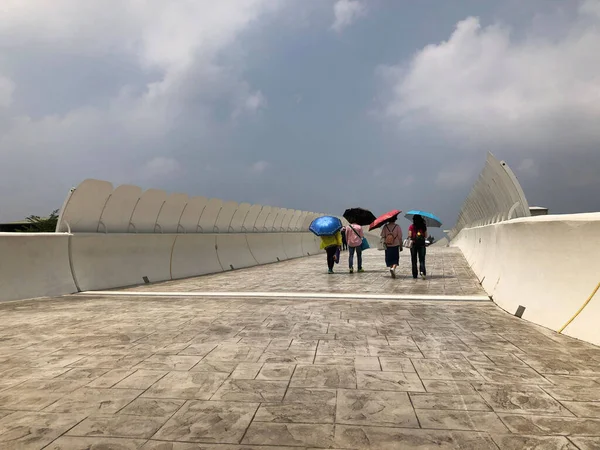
0, 0, 600, 232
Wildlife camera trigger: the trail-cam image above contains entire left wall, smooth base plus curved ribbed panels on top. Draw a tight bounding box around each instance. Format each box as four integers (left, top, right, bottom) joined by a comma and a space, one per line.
0, 179, 346, 301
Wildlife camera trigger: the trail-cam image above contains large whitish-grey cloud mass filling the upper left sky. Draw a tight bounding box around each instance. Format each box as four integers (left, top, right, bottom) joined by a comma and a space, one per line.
0, 0, 281, 219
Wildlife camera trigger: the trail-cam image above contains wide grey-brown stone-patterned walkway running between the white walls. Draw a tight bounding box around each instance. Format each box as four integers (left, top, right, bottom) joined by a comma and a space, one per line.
0, 249, 600, 450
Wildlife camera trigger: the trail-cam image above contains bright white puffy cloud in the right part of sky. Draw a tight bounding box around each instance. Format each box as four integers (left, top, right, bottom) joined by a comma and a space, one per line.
380, 0, 600, 152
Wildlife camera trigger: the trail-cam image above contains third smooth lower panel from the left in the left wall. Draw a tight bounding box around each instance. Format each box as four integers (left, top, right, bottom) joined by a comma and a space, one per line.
171, 233, 223, 280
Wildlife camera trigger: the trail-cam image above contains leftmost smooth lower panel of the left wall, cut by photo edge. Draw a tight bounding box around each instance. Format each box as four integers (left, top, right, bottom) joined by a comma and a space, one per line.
0, 233, 77, 301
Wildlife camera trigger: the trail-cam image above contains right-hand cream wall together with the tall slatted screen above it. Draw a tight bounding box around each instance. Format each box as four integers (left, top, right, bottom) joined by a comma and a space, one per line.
449, 155, 600, 345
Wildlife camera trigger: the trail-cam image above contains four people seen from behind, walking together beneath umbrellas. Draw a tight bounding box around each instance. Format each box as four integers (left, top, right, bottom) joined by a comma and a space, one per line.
321, 215, 428, 279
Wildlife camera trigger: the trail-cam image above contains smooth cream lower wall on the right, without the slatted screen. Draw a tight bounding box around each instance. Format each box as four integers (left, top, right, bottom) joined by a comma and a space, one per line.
450, 213, 600, 345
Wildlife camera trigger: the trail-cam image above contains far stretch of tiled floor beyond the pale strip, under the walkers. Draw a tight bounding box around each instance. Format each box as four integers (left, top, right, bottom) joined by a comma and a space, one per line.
123, 247, 485, 295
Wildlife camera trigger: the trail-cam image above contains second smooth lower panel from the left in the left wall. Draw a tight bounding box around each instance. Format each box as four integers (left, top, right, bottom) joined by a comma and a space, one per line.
71, 233, 176, 291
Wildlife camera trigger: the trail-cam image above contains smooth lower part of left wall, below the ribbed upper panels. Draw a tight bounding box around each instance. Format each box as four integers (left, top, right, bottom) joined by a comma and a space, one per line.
0, 233, 320, 301
